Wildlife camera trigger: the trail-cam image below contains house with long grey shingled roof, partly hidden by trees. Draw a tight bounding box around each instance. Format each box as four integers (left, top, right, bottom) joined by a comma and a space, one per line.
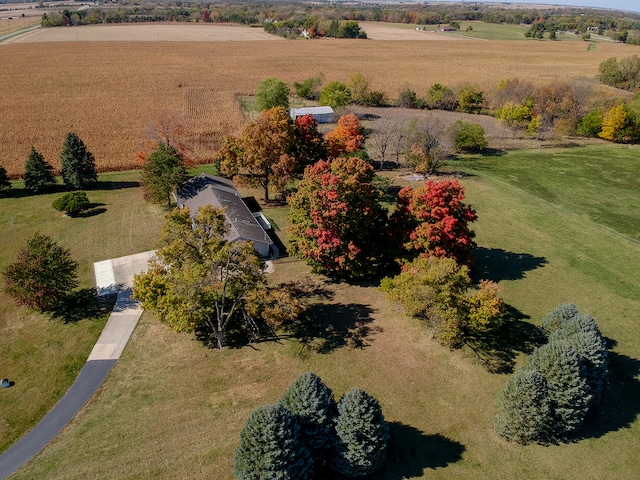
175, 173, 277, 258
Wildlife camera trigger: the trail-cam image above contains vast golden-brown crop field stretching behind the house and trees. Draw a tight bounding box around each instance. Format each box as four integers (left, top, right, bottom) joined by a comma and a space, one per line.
0, 25, 640, 176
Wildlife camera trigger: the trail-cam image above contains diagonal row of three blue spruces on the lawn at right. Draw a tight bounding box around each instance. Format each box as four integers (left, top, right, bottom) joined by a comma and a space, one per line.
494, 304, 608, 444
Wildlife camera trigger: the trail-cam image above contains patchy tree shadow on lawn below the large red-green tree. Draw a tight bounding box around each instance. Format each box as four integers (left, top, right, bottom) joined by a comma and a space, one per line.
283, 302, 382, 353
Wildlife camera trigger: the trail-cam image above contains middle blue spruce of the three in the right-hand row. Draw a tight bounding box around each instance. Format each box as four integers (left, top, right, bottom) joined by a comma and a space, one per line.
527, 338, 591, 438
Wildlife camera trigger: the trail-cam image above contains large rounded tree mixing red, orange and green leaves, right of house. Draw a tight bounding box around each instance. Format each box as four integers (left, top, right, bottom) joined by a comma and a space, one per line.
289, 158, 386, 278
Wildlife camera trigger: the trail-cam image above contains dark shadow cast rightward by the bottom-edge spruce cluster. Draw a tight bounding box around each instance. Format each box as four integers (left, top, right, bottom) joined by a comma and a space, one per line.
371, 422, 465, 480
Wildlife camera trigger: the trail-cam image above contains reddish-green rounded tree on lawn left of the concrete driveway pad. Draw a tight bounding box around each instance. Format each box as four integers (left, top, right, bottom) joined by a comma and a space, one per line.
3, 233, 78, 311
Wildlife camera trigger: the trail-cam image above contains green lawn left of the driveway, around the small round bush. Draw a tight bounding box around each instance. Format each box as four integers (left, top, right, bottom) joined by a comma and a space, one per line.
0, 172, 163, 451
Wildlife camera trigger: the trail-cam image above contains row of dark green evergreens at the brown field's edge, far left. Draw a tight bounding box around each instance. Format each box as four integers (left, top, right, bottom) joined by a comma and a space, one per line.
0, 132, 98, 194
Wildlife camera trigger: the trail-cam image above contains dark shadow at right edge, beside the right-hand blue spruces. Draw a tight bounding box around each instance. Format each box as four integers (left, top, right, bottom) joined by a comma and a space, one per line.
579, 341, 640, 438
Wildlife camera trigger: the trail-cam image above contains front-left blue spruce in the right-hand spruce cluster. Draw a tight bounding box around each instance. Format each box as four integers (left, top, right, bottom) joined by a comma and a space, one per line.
494, 369, 553, 444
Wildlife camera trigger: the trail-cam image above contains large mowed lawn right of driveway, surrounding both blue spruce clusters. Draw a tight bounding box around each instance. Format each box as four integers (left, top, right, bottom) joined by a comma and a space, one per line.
5, 147, 640, 480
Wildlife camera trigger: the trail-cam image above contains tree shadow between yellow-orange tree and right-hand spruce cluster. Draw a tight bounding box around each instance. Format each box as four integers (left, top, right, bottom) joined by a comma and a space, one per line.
465, 305, 546, 373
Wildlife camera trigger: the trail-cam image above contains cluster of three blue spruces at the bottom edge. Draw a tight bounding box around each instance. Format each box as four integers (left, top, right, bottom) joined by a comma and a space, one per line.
233, 372, 389, 480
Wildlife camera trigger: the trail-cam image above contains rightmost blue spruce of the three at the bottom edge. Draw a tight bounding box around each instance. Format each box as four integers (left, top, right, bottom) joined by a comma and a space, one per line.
331, 388, 389, 477
